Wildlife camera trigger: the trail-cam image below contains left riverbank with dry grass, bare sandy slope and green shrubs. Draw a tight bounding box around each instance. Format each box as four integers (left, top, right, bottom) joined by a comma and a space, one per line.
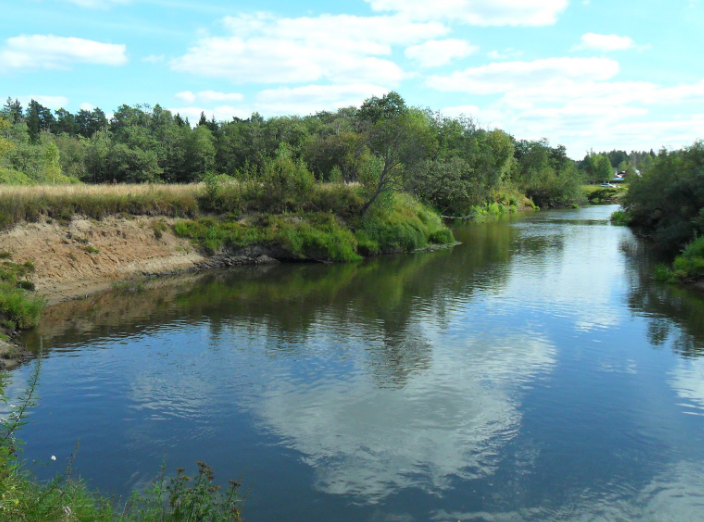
0, 180, 454, 366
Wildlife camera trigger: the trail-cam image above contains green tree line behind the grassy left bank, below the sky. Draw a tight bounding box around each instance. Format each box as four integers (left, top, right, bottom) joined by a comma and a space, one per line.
0, 92, 632, 215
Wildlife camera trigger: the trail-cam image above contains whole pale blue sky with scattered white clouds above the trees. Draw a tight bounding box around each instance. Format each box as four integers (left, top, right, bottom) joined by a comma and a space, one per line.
0, 0, 704, 159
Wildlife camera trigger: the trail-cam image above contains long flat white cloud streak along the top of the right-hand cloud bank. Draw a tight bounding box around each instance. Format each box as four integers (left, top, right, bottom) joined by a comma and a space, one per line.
427, 58, 619, 94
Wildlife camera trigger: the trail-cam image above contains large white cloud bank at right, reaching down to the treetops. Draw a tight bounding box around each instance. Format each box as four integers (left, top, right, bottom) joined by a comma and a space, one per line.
428, 58, 704, 158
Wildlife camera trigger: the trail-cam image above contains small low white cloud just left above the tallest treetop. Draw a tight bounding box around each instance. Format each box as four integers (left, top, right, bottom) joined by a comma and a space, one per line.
256, 84, 389, 114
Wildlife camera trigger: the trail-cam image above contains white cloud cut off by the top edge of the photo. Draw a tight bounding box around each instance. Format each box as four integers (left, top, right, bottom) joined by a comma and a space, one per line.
365, 0, 567, 26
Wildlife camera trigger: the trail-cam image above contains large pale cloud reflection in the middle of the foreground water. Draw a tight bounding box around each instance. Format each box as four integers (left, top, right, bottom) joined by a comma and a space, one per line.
254, 336, 555, 503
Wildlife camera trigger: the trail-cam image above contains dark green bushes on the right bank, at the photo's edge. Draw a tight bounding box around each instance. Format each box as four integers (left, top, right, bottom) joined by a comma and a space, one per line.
614, 141, 704, 281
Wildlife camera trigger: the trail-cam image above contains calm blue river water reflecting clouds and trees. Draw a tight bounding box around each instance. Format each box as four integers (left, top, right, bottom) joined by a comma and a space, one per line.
9, 206, 704, 522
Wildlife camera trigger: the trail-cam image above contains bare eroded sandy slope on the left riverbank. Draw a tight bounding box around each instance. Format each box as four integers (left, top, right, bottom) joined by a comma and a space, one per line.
0, 217, 206, 304
